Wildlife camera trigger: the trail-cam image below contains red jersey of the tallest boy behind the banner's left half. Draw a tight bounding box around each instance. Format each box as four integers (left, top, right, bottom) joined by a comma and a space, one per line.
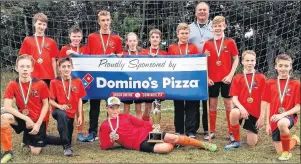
88, 32, 122, 55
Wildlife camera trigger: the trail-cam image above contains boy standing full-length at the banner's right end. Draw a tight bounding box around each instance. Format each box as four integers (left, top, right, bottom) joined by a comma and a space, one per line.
202, 16, 239, 141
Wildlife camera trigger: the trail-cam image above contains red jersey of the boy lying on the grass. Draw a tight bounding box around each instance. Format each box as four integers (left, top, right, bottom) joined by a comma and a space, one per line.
99, 114, 153, 150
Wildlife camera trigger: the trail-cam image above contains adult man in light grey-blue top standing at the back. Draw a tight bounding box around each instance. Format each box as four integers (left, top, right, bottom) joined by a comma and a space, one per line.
189, 2, 213, 140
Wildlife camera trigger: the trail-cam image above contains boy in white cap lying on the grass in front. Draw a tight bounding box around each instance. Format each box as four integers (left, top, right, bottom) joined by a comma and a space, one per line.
99, 97, 217, 153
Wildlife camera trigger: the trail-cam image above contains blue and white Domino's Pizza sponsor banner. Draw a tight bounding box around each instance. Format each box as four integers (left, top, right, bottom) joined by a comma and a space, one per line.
72, 55, 208, 100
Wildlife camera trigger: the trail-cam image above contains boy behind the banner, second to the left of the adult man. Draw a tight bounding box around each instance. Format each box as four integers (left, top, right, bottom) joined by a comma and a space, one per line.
142, 29, 167, 121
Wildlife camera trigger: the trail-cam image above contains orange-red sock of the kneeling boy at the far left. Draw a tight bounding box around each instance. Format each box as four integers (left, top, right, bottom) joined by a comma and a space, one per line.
1, 126, 13, 152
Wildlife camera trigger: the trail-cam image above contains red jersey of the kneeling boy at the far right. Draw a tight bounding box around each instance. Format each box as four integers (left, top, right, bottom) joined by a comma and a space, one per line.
262, 78, 301, 131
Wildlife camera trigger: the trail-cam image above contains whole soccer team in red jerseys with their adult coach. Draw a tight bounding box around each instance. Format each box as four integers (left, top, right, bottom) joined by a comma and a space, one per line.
1, 2, 300, 163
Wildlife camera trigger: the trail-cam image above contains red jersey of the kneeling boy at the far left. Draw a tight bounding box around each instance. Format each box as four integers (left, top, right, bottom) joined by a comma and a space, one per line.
3, 78, 49, 122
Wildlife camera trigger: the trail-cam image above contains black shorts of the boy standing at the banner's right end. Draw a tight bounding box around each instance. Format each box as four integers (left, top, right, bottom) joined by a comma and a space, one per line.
209, 82, 232, 98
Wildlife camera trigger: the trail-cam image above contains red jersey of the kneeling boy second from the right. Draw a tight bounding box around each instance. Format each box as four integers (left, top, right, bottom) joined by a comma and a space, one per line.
230, 73, 266, 118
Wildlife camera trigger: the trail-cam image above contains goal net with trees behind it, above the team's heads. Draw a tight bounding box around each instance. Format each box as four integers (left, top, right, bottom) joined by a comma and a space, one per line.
0, 0, 301, 76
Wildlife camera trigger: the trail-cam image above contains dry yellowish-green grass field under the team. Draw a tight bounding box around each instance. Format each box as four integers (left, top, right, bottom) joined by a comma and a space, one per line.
1, 72, 300, 163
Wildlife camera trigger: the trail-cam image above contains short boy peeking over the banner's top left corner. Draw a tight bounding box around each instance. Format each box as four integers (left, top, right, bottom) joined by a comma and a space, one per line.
59, 25, 89, 58
